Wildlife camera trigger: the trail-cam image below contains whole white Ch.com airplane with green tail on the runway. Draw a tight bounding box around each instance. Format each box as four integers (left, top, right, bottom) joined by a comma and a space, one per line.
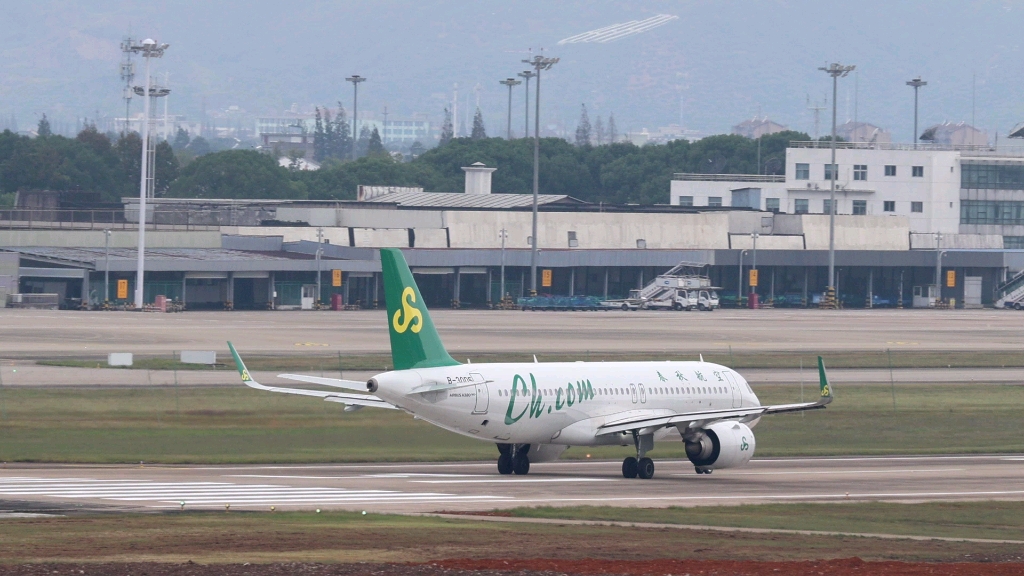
227, 248, 833, 480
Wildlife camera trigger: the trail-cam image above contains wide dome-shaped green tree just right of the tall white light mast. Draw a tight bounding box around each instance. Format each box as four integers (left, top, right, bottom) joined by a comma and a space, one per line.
167, 150, 305, 199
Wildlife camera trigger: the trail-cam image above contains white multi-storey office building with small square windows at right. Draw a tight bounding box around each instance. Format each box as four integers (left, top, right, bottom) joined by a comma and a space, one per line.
671, 141, 1024, 248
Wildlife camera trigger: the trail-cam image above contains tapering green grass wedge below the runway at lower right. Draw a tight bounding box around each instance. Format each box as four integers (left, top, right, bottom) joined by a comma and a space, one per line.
503, 501, 1024, 540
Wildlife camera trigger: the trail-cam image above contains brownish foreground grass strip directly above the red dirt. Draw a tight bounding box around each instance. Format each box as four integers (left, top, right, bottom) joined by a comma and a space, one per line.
0, 505, 1021, 564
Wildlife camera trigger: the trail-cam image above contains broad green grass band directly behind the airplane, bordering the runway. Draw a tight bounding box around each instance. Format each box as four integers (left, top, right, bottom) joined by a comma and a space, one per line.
0, 384, 1024, 463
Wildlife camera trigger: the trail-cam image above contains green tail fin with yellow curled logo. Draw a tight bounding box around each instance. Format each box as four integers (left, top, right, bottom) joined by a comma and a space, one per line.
381, 248, 459, 370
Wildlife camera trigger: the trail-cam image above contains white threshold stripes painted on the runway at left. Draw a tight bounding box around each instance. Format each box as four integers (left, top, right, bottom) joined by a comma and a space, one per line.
0, 477, 498, 505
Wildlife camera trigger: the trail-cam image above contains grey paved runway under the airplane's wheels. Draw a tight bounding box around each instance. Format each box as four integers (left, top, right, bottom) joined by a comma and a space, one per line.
0, 455, 1024, 515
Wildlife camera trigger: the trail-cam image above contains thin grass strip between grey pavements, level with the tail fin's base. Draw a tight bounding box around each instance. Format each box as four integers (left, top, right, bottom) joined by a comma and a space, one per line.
37, 349, 1024, 372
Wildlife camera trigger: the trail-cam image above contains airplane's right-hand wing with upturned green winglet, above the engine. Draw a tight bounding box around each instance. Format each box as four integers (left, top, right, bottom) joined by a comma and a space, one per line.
597, 356, 833, 436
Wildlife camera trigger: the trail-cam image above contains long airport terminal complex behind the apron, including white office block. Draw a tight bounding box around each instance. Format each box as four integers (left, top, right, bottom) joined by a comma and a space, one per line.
0, 148, 1024, 310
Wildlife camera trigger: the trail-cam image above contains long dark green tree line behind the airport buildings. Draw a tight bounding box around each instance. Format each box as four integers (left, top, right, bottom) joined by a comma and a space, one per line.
0, 116, 810, 204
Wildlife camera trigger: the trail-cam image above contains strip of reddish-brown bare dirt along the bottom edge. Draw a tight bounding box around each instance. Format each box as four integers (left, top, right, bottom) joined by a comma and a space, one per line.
0, 558, 1024, 576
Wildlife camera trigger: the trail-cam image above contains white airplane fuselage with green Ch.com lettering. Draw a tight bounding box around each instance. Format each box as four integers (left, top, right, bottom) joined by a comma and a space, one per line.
374, 362, 760, 446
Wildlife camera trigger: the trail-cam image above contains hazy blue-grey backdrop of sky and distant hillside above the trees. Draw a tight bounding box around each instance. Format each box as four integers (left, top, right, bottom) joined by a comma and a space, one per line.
0, 0, 1024, 140
